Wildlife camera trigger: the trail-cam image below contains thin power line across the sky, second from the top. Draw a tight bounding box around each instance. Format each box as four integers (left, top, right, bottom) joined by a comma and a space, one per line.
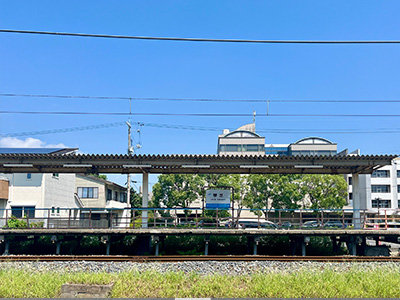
0, 93, 400, 103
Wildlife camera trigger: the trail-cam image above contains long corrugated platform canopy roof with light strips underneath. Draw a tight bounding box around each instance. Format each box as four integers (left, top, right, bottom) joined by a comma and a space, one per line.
0, 153, 397, 174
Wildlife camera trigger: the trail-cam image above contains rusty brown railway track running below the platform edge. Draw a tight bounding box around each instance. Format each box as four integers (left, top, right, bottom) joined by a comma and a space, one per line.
0, 255, 400, 263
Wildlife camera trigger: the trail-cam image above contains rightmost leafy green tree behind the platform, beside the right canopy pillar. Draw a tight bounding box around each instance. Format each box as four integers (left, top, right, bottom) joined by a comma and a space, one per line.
301, 174, 347, 209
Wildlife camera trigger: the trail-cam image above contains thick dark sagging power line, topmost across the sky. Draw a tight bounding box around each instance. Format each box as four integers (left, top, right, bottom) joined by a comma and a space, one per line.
0, 29, 400, 44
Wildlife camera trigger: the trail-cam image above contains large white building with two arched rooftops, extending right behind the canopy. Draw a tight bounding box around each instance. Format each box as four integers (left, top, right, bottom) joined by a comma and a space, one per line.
218, 124, 400, 214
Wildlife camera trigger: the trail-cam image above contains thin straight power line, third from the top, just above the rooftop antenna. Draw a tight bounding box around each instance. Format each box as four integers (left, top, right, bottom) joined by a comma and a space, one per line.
0, 111, 400, 118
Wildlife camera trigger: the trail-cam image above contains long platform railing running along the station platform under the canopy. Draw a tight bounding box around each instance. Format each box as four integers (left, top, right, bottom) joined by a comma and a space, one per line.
0, 207, 400, 230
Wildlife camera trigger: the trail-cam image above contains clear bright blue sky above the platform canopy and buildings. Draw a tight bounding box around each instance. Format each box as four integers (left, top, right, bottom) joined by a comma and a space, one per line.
0, 0, 400, 185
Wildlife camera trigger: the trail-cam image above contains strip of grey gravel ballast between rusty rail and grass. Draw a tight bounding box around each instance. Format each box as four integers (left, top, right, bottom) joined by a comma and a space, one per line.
0, 261, 400, 276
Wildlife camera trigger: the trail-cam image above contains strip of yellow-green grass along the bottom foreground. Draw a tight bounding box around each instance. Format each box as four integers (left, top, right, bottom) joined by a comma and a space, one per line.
0, 268, 400, 298
